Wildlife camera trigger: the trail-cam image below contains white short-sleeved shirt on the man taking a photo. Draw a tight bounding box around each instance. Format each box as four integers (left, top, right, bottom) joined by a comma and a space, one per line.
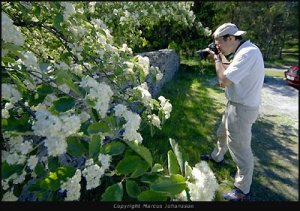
224, 41, 265, 107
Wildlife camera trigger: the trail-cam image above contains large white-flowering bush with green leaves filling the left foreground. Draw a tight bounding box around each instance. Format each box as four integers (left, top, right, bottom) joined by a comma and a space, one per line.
1, 2, 217, 201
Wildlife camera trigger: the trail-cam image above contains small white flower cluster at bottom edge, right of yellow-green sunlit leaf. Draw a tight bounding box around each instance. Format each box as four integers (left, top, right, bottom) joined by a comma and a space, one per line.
61, 169, 81, 201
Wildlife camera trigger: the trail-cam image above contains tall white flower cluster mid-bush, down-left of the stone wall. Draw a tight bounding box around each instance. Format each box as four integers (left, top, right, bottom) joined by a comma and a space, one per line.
80, 76, 114, 118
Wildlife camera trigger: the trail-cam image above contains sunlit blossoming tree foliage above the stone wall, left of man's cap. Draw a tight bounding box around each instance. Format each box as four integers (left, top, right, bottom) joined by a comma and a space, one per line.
94, 1, 211, 52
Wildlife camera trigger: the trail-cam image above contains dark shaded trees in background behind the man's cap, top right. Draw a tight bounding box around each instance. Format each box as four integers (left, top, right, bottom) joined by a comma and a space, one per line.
193, 1, 299, 60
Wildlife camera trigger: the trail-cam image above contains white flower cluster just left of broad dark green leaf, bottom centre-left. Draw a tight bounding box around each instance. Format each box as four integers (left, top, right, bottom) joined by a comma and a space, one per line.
82, 153, 111, 190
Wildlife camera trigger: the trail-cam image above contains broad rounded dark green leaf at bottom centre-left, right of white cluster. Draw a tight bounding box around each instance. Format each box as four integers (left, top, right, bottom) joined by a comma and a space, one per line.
116, 155, 149, 178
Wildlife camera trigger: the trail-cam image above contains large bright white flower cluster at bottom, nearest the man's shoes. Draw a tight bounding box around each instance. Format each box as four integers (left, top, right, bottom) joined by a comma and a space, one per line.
187, 161, 219, 201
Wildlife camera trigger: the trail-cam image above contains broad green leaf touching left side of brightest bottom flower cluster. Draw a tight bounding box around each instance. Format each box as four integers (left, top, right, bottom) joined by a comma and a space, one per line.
150, 174, 186, 196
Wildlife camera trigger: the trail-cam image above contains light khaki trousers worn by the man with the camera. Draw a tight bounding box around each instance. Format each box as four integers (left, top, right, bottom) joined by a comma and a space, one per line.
211, 101, 259, 194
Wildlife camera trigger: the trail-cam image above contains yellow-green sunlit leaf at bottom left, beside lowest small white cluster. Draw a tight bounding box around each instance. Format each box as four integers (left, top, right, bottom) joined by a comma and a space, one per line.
39, 166, 76, 191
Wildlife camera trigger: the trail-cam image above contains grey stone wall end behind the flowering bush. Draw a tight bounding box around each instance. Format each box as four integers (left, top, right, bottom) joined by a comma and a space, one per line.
139, 49, 180, 97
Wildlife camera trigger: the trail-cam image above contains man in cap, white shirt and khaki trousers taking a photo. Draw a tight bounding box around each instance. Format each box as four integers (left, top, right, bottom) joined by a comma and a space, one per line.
201, 23, 264, 201
